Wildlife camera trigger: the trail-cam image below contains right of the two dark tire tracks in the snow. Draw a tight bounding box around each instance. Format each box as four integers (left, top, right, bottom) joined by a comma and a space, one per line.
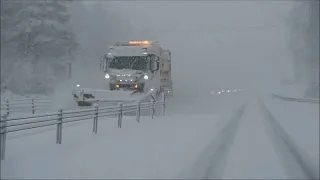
260, 99, 319, 179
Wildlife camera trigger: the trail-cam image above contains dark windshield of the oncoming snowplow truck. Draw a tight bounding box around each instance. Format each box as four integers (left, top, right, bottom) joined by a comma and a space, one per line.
109, 56, 147, 71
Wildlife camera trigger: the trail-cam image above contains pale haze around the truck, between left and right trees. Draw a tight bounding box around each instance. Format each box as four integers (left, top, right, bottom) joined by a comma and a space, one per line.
54, 1, 292, 109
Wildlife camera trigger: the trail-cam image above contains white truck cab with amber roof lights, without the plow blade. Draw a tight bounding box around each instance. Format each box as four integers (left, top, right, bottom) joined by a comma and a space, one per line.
102, 40, 172, 93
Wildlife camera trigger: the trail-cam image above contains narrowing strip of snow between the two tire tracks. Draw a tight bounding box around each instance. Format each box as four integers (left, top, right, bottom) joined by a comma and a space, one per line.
223, 100, 286, 179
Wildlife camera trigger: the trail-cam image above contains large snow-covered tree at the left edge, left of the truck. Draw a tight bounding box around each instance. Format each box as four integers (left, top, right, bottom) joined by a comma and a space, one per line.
1, 0, 77, 93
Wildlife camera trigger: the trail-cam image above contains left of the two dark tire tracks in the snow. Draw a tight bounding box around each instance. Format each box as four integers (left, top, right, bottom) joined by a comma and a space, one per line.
187, 104, 246, 179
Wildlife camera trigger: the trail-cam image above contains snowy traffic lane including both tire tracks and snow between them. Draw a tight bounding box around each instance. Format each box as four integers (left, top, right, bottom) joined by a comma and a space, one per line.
184, 95, 319, 179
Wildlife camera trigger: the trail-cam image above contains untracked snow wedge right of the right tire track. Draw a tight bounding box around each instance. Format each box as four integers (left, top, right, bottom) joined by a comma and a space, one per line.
264, 97, 320, 174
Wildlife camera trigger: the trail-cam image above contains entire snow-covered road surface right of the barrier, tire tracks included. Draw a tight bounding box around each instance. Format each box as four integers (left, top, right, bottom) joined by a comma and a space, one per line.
1, 94, 319, 179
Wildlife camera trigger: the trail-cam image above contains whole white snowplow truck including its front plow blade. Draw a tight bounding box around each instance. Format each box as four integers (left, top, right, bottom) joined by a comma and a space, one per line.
74, 40, 173, 106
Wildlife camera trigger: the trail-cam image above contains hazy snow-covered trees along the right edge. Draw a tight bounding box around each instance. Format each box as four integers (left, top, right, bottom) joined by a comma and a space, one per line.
289, 0, 319, 96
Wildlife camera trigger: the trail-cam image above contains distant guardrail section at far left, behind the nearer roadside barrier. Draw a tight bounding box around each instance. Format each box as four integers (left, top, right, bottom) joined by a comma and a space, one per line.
1, 98, 51, 115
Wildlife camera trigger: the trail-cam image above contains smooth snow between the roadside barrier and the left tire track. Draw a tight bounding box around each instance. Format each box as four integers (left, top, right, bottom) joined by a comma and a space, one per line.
1, 113, 224, 179
